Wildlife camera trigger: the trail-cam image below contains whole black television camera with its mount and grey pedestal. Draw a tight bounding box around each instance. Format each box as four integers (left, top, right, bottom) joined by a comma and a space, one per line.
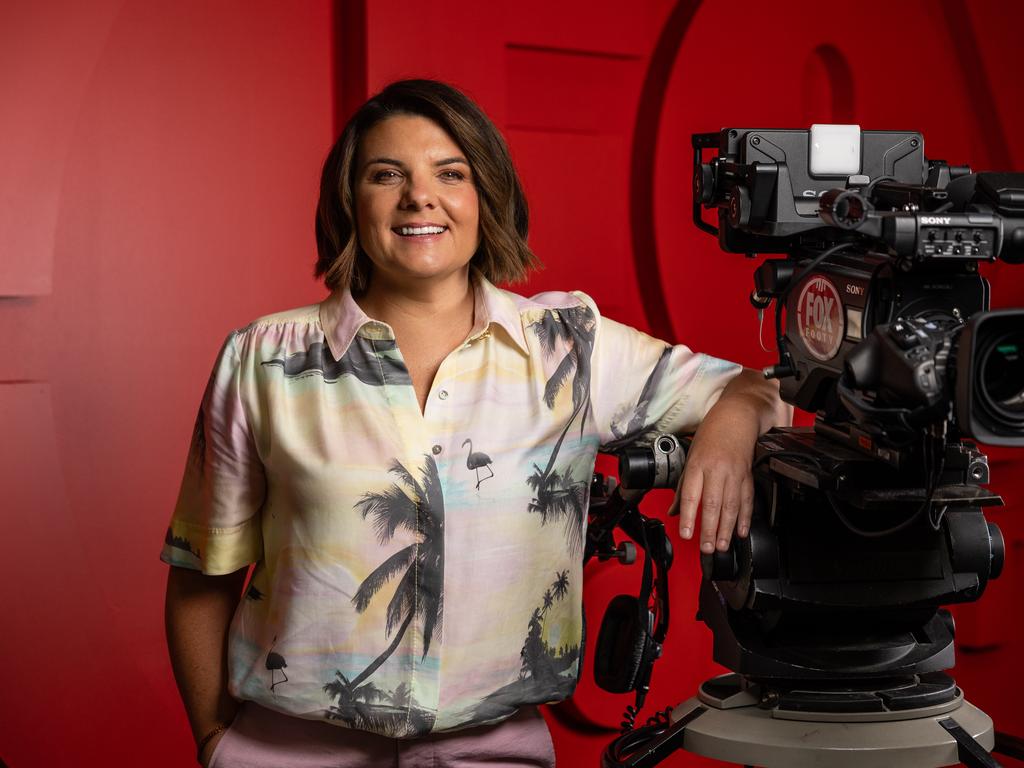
597, 125, 1024, 768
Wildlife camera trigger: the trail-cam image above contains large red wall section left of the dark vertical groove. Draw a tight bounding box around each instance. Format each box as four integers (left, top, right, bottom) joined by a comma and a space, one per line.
0, 0, 334, 768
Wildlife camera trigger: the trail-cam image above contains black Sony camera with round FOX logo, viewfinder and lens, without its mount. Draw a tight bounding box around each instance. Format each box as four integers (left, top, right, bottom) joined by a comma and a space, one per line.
693, 126, 1024, 445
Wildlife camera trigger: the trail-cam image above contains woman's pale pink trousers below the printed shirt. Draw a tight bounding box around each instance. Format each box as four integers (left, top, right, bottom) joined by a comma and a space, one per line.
209, 701, 555, 768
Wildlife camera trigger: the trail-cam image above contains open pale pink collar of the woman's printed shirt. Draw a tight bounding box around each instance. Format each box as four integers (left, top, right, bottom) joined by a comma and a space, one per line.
319, 268, 529, 360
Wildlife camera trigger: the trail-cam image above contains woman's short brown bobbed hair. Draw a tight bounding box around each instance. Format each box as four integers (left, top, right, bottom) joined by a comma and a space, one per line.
315, 80, 540, 291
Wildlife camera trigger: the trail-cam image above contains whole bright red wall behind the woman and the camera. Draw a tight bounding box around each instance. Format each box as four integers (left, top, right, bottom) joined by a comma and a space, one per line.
0, 0, 1024, 768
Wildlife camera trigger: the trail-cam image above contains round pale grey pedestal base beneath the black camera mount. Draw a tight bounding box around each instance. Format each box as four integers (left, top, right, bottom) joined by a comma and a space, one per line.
671, 675, 994, 768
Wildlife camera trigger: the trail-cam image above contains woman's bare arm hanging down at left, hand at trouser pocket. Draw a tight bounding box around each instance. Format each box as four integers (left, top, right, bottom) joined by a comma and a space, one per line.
164, 566, 248, 765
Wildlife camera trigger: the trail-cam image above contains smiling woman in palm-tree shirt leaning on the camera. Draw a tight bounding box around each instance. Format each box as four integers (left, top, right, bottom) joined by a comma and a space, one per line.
162, 81, 785, 768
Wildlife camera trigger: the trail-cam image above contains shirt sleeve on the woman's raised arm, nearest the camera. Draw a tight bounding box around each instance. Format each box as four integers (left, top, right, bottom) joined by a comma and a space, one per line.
577, 293, 742, 451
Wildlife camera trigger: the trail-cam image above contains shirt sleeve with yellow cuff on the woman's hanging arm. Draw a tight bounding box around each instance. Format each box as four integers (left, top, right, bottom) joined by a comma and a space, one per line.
160, 333, 266, 575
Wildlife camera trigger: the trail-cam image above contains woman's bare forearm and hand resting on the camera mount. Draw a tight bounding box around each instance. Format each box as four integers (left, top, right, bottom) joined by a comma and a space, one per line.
669, 369, 793, 553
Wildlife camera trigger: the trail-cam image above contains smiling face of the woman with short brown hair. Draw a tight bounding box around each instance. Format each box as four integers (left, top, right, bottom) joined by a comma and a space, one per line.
354, 115, 479, 285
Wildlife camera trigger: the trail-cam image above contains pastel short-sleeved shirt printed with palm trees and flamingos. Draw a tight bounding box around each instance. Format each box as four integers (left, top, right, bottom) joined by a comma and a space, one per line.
162, 273, 739, 737
